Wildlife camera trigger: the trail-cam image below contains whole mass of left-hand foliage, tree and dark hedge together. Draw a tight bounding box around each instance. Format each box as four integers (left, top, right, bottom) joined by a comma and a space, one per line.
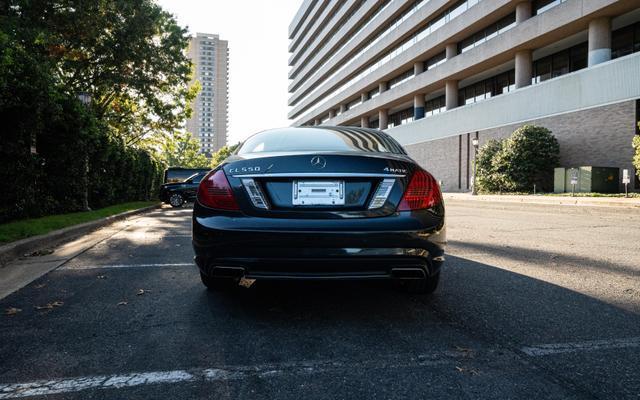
0, 0, 188, 222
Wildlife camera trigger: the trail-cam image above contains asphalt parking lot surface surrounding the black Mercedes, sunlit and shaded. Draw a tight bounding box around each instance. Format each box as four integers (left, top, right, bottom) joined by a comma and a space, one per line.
0, 202, 640, 399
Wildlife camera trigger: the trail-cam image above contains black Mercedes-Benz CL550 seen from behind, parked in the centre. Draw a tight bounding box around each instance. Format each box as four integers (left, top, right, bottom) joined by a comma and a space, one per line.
193, 126, 446, 293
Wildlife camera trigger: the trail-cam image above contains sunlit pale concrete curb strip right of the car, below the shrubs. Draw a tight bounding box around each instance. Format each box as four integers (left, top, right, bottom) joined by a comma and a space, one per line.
443, 193, 640, 209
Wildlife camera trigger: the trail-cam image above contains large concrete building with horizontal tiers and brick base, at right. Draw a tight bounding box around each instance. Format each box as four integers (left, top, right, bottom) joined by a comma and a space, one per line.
289, 0, 640, 191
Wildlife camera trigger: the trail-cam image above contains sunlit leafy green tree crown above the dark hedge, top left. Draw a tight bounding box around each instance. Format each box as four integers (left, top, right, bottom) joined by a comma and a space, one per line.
0, 0, 197, 144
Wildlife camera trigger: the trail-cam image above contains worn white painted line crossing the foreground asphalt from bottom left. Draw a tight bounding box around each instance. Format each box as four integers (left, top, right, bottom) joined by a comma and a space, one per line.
0, 351, 460, 399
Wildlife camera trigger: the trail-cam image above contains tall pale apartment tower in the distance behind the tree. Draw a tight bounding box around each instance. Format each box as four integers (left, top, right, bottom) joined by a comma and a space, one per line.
187, 33, 229, 156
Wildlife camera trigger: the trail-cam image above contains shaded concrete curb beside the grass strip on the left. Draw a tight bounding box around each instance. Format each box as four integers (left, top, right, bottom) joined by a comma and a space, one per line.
0, 203, 162, 267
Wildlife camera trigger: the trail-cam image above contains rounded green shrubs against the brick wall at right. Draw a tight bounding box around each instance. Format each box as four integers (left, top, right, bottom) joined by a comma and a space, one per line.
478, 125, 560, 192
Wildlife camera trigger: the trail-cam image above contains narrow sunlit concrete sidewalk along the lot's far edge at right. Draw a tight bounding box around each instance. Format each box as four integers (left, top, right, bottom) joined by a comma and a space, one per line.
443, 193, 640, 209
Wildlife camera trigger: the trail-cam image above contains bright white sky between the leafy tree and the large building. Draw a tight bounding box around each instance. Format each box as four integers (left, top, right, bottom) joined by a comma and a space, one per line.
157, 0, 301, 144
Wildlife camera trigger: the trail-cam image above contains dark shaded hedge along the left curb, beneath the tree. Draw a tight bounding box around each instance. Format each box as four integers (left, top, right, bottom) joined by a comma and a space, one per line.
0, 38, 163, 223
